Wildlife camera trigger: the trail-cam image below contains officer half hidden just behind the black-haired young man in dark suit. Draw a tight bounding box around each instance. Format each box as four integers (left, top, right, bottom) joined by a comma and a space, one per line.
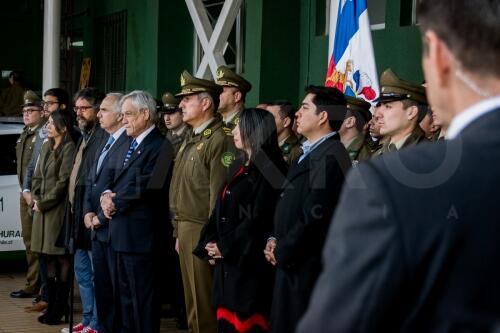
339, 96, 372, 166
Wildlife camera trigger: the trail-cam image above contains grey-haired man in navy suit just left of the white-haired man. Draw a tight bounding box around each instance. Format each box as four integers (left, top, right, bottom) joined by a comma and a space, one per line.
84, 93, 131, 333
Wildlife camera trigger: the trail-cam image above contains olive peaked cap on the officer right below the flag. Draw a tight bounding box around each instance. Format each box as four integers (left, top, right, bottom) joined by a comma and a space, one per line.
377, 68, 427, 104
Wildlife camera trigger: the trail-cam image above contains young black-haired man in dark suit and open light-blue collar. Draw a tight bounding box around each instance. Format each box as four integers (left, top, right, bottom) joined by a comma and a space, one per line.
264, 86, 351, 333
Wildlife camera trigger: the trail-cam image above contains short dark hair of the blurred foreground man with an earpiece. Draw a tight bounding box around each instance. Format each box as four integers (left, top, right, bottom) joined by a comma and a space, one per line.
418, 0, 500, 76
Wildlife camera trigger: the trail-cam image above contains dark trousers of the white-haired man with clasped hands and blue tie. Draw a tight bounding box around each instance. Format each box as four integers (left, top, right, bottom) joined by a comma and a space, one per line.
115, 252, 160, 333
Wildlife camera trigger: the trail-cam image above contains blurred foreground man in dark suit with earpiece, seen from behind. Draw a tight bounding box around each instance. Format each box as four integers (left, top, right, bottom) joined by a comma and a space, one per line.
298, 0, 500, 333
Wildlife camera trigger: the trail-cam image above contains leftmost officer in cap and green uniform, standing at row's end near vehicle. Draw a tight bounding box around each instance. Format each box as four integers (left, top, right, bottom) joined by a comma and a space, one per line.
10, 90, 44, 298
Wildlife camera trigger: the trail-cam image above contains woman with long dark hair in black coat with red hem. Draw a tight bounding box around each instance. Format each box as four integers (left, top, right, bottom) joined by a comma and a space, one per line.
194, 109, 286, 332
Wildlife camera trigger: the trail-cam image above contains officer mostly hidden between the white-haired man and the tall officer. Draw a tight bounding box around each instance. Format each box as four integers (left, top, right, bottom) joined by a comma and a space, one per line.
161, 92, 191, 154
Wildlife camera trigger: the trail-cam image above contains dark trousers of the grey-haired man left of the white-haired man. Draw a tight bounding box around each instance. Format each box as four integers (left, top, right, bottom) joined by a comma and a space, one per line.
92, 240, 121, 333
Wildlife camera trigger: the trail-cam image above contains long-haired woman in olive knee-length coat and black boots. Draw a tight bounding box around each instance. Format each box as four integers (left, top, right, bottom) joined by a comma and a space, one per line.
31, 111, 75, 325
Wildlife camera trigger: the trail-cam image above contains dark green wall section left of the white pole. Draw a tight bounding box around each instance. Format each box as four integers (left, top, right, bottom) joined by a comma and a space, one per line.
0, 0, 43, 91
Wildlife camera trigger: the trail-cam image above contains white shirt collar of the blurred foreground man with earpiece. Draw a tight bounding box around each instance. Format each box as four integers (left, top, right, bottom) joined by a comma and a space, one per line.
446, 96, 500, 140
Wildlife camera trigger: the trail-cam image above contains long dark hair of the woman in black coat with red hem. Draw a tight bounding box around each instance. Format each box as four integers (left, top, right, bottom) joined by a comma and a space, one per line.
239, 108, 282, 161
